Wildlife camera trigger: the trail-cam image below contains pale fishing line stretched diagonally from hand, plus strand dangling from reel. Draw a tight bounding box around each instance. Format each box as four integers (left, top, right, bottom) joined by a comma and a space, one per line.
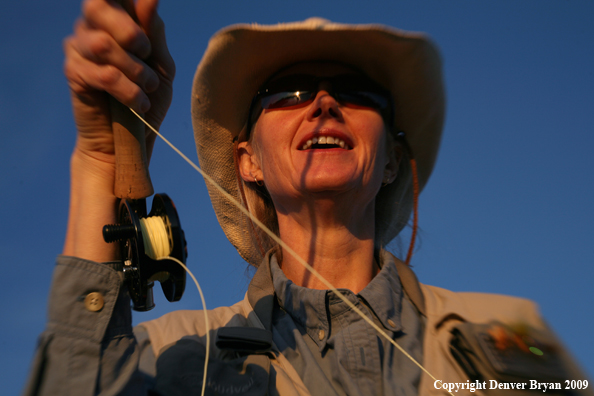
130, 108, 454, 396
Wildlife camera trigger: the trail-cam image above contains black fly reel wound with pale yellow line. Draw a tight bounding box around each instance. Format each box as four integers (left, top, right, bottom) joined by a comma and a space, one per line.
103, 194, 188, 311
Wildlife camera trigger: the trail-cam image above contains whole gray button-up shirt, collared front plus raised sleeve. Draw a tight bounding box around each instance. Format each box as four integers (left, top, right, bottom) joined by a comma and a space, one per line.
24, 252, 422, 396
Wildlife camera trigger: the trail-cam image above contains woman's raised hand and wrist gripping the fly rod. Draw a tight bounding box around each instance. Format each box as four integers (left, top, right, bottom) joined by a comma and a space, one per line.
64, 0, 175, 164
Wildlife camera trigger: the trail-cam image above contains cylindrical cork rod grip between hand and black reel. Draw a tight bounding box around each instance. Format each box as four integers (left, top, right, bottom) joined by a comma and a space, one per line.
110, 98, 154, 199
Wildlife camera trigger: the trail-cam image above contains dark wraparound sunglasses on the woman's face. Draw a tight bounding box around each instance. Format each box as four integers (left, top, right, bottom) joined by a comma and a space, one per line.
250, 74, 392, 128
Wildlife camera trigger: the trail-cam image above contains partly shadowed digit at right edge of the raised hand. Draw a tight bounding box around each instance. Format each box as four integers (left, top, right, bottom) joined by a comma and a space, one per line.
136, 0, 175, 81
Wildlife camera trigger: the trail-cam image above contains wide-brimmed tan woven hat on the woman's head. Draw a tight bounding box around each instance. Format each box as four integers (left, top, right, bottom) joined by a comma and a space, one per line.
192, 18, 445, 266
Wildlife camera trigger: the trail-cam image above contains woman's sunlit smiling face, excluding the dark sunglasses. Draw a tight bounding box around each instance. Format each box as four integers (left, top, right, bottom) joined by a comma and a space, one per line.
240, 62, 398, 210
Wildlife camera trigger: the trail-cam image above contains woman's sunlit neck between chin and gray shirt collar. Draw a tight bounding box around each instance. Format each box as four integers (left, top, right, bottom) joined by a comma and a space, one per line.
277, 199, 378, 293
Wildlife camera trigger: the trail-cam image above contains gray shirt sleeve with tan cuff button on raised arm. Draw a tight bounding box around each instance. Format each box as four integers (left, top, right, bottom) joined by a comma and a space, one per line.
23, 256, 154, 396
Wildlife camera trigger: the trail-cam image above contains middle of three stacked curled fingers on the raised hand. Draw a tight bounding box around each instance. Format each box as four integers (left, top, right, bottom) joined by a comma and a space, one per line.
72, 21, 159, 92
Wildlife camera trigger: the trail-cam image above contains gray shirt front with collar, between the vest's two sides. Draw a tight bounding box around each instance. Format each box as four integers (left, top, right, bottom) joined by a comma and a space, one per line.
270, 255, 423, 395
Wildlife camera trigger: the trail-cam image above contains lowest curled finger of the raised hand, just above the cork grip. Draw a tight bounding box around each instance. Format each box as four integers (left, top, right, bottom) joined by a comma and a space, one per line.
64, 39, 150, 112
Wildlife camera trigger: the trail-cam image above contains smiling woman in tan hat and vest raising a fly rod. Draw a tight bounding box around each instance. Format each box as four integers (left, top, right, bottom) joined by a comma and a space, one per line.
23, 0, 588, 395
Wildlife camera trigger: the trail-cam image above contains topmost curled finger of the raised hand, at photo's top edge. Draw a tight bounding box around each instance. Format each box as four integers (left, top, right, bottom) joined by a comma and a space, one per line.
83, 0, 151, 59
